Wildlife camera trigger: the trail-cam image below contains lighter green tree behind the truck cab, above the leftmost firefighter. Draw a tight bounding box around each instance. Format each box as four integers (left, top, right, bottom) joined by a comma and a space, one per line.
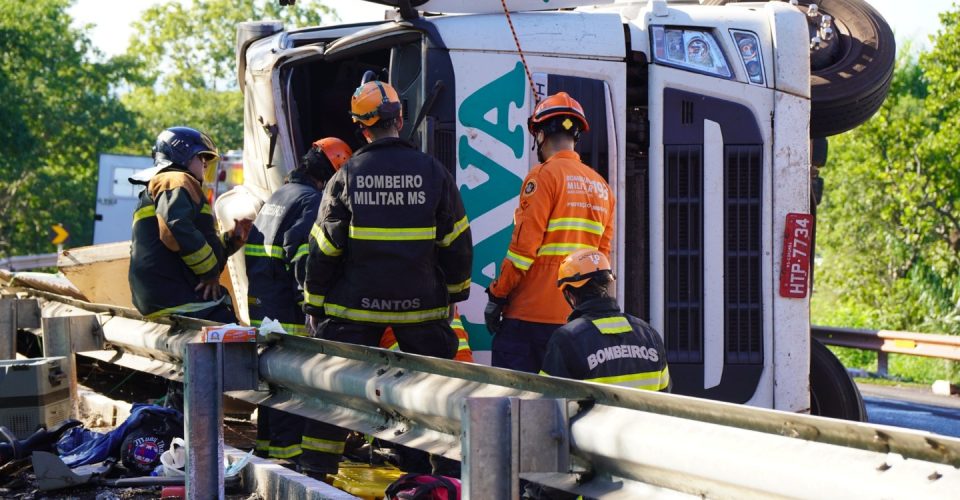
123, 0, 335, 151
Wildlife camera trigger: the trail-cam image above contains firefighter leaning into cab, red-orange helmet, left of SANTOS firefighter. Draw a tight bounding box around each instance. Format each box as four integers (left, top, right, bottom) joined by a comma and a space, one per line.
244, 137, 353, 470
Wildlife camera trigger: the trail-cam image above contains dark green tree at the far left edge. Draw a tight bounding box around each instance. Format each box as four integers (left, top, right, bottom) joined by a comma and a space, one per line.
0, 0, 142, 255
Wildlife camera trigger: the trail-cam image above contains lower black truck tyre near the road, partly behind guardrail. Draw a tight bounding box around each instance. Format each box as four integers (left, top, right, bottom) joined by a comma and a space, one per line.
810, 339, 867, 422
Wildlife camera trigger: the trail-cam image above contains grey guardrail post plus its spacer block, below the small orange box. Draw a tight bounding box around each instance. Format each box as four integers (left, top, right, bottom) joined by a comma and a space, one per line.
183, 342, 259, 499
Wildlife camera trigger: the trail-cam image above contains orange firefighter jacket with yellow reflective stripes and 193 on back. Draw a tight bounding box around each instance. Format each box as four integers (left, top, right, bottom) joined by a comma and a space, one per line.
489, 151, 615, 325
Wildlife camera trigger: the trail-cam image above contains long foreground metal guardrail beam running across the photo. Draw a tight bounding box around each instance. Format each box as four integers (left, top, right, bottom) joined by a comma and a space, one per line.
5, 292, 960, 498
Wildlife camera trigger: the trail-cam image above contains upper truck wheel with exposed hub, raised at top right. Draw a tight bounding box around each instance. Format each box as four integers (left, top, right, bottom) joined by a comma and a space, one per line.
700, 0, 896, 137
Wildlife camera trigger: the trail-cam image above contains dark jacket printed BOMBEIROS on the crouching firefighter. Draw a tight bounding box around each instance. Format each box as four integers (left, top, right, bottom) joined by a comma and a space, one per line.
540, 297, 671, 392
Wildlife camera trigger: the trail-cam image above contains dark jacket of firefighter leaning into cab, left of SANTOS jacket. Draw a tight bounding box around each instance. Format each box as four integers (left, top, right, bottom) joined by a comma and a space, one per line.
243, 170, 322, 335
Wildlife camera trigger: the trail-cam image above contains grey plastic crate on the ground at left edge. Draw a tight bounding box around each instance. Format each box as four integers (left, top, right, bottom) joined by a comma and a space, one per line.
0, 356, 71, 439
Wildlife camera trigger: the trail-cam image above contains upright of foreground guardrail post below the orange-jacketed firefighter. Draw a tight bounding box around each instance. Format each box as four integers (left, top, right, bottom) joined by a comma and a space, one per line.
460, 398, 520, 500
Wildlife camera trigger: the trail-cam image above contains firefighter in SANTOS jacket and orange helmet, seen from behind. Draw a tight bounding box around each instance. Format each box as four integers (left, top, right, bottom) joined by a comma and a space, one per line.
304, 77, 473, 472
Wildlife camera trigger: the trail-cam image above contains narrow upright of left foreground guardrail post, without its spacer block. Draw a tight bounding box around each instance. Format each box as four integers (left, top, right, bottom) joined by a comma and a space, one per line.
183, 343, 224, 499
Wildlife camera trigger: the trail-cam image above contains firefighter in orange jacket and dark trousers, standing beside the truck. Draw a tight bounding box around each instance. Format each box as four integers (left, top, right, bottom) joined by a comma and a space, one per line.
484, 92, 614, 373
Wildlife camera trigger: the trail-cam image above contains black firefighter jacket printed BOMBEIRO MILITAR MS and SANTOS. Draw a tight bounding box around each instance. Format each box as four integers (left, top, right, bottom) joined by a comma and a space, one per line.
304, 138, 473, 325
